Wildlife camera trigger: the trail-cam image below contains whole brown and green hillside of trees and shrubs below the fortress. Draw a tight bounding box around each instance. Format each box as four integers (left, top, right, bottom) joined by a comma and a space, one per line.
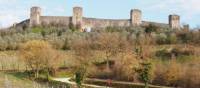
0, 26, 200, 88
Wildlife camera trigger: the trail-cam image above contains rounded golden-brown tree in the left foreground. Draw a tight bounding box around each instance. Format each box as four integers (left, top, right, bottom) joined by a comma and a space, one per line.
20, 40, 59, 78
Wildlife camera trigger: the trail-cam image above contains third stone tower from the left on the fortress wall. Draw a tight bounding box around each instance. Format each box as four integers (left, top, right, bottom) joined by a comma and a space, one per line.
131, 9, 142, 26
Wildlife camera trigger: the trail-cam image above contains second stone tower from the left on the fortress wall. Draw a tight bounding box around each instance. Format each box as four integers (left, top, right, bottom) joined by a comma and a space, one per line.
72, 7, 83, 27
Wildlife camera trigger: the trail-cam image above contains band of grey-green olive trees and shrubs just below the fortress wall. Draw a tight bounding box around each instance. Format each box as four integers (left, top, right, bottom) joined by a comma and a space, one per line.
0, 25, 200, 50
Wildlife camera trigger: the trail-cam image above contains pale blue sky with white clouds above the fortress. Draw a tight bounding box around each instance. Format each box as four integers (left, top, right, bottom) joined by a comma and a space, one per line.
0, 0, 200, 27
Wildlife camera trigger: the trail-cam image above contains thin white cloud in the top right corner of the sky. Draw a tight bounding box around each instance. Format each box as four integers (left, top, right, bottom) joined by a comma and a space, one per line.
144, 0, 200, 14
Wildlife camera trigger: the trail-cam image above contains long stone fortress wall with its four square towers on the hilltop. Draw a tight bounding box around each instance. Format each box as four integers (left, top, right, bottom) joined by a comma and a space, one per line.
29, 7, 183, 29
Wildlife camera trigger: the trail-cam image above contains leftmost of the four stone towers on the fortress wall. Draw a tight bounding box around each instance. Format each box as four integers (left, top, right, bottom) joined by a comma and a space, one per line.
30, 7, 41, 27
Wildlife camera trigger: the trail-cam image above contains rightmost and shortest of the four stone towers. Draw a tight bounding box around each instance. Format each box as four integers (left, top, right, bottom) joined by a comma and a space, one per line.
169, 15, 180, 29
